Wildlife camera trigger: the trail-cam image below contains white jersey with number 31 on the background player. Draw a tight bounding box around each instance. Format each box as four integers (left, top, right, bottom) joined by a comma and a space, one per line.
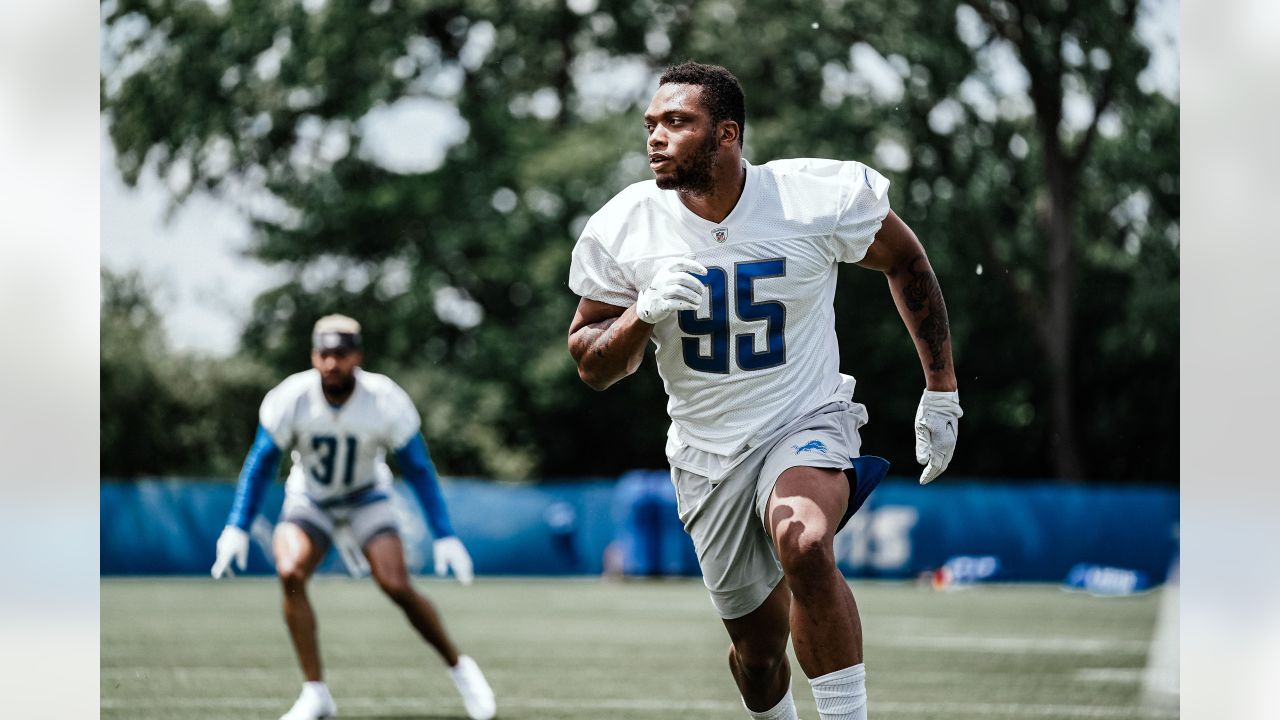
259, 368, 422, 501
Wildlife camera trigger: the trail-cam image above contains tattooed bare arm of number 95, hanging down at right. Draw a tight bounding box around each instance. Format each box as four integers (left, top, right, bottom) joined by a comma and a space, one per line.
858, 210, 956, 392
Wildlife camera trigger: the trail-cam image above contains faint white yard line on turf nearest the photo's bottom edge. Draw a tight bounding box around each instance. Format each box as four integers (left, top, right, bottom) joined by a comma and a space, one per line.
102, 697, 1178, 720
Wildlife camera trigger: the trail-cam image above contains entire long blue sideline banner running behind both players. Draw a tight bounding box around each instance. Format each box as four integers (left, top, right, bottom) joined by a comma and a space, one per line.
100, 471, 1179, 582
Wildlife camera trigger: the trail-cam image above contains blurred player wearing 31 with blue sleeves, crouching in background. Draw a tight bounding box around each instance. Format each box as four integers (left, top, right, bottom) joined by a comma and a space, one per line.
211, 315, 495, 720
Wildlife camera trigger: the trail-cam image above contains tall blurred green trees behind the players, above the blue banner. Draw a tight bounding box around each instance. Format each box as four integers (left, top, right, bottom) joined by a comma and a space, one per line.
102, 0, 1178, 482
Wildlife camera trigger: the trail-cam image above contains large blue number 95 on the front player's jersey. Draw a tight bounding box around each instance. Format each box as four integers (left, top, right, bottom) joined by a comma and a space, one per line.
677, 258, 787, 374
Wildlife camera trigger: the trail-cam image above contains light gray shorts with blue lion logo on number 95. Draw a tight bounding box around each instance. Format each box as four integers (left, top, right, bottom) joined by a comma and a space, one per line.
669, 401, 867, 620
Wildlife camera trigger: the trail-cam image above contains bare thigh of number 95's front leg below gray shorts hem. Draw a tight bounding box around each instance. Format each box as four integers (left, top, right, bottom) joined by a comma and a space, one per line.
764, 465, 849, 548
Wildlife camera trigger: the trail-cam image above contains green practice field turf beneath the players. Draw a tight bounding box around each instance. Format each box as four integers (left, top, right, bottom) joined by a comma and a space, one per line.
101, 578, 1178, 720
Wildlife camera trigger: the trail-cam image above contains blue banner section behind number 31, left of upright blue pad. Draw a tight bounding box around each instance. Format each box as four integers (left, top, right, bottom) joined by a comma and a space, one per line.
100, 479, 617, 575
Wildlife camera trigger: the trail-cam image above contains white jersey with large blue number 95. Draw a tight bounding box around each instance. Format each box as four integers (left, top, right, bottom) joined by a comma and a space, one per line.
568, 159, 888, 455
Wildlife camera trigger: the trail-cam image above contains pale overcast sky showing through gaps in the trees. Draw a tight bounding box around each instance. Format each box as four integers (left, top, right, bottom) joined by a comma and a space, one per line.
101, 0, 1179, 355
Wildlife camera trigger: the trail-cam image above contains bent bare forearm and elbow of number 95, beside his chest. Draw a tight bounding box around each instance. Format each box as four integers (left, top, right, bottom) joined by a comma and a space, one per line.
568, 297, 653, 389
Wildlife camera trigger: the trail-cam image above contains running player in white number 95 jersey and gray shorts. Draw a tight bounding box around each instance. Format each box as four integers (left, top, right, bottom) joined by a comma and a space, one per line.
568, 63, 961, 720
